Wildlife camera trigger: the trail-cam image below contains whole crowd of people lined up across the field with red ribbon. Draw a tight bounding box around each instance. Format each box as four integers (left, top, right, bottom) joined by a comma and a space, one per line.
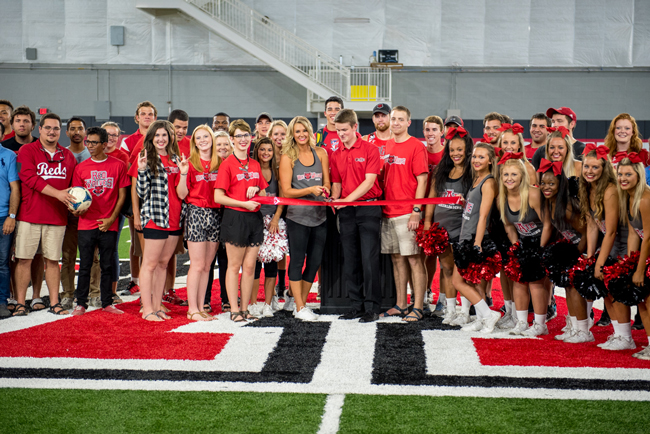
0, 97, 650, 360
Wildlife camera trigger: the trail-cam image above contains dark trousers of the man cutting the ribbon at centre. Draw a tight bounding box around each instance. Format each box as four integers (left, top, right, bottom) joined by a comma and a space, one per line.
339, 206, 381, 313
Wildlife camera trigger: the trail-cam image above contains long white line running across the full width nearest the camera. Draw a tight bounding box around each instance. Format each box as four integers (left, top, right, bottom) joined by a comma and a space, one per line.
0, 378, 650, 401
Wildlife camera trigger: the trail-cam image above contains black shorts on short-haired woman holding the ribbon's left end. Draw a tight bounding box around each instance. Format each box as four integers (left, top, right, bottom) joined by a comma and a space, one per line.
219, 208, 264, 247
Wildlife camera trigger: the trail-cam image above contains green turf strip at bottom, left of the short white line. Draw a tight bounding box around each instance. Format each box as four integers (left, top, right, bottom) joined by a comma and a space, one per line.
0, 389, 325, 434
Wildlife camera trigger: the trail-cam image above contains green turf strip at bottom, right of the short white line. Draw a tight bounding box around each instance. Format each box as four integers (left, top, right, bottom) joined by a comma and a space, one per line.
339, 392, 650, 434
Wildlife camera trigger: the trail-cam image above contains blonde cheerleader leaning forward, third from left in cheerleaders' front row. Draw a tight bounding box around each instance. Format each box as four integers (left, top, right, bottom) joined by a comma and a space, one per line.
497, 153, 551, 337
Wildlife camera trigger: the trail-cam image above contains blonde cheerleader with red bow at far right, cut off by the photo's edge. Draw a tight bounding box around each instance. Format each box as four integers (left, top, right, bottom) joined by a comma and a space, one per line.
608, 153, 650, 360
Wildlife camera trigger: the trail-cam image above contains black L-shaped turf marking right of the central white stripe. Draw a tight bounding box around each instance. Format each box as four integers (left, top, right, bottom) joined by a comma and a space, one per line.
372, 317, 650, 391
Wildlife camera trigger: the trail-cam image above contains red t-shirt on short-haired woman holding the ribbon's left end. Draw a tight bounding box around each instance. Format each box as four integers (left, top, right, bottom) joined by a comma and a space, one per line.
215, 155, 268, 212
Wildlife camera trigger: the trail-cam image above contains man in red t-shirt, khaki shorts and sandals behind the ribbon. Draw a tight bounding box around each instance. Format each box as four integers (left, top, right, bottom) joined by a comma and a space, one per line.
381, 106, 428, 321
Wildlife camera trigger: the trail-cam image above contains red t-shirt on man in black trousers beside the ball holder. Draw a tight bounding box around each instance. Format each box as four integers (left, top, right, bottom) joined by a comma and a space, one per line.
72, 156, 131, 231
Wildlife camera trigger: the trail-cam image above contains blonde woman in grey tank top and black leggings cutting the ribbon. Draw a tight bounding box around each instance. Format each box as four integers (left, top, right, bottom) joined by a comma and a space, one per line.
280, 116, 330, 321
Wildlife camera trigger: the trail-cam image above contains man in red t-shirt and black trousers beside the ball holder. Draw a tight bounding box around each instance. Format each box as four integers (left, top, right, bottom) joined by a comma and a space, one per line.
72, 127, 131, 315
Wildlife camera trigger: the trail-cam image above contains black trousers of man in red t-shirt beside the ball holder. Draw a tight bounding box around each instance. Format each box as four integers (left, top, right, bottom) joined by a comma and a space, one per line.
75, 229, 117, 308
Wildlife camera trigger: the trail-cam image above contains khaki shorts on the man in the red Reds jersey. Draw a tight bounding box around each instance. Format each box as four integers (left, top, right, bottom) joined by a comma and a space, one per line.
16, 222, 65, 261
